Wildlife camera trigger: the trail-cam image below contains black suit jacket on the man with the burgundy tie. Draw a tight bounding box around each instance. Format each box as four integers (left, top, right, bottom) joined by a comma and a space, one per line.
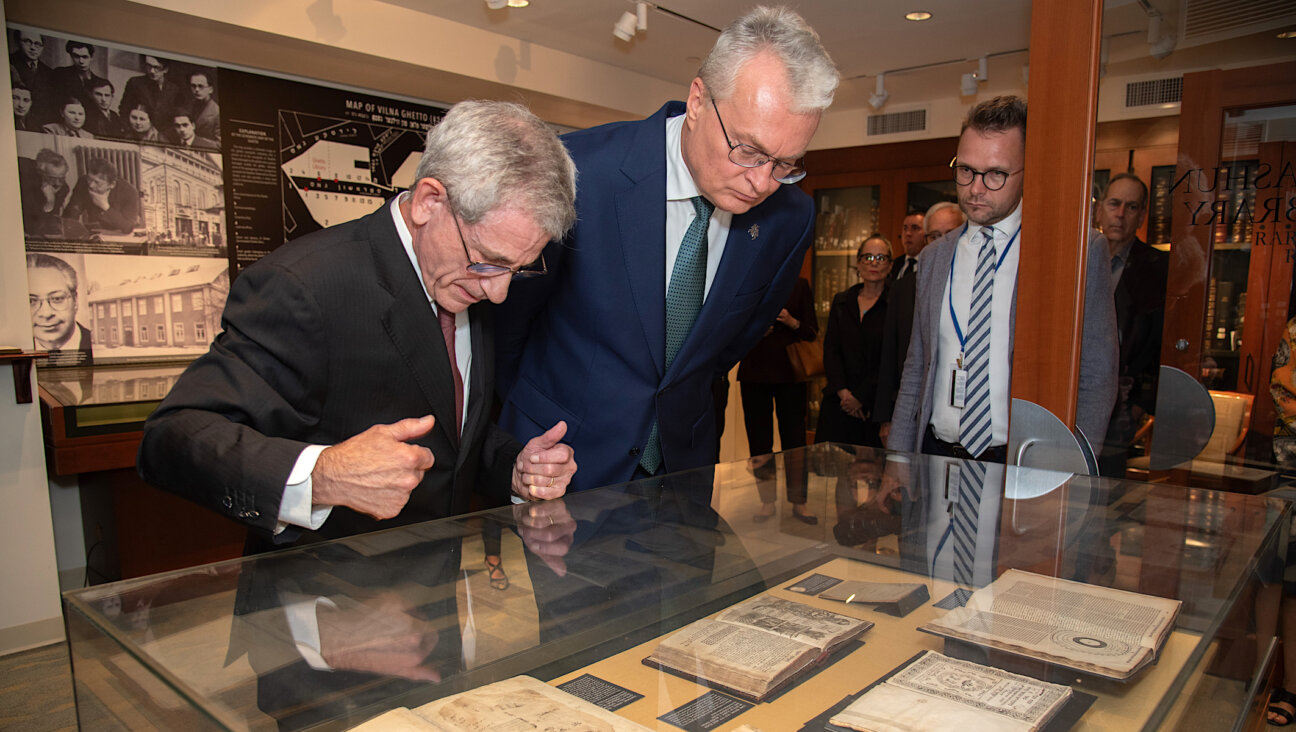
139, 205, 520, 549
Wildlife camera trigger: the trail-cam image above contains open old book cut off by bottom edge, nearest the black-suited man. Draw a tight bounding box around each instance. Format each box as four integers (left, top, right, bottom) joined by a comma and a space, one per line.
351, 676, 648, 732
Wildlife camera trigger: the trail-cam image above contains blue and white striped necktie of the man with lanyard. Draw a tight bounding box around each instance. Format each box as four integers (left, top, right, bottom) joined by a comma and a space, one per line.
959, 227, 995, 457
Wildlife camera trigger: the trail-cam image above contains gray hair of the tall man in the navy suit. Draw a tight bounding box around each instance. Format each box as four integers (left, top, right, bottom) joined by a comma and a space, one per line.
697, 5, 841, 114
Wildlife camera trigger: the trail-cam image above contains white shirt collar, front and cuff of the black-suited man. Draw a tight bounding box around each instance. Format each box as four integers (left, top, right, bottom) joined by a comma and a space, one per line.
275, 192, 474, 534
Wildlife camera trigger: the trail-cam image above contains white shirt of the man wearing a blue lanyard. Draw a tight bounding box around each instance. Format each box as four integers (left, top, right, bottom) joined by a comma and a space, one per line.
932, 202, 1021, 446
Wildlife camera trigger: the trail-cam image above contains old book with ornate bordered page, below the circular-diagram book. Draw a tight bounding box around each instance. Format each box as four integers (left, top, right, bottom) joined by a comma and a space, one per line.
829, 650, 1072, 732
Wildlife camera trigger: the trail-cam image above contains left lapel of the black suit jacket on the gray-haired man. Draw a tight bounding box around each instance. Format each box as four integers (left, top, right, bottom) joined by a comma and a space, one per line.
368, 202, 463, 444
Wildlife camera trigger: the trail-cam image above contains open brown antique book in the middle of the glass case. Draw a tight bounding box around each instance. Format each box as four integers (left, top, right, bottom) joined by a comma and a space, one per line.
644, 596, 874, 702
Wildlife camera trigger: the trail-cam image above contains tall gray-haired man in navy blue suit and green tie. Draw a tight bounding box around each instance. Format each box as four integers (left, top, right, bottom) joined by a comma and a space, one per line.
496, 8, 839, 490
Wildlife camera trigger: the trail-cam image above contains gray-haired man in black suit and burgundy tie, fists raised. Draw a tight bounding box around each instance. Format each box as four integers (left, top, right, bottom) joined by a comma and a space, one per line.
137, 102, 575, 552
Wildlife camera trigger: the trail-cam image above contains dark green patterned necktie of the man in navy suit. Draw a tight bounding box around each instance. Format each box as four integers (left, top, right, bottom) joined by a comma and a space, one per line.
639, 196, 715, 475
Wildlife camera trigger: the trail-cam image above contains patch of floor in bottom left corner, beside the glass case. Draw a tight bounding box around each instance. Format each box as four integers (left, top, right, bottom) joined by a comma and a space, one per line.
0, 643, 76, 732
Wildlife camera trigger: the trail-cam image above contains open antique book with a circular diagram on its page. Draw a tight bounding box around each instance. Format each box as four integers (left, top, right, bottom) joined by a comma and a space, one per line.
919, 570, 1182, 680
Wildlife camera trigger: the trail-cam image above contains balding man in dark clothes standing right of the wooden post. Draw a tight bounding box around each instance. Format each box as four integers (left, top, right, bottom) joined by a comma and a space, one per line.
1096, 172, 1170, 478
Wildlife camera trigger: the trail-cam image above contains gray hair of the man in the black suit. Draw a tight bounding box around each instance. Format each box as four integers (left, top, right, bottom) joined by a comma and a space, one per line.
416, 101, 575, 238
